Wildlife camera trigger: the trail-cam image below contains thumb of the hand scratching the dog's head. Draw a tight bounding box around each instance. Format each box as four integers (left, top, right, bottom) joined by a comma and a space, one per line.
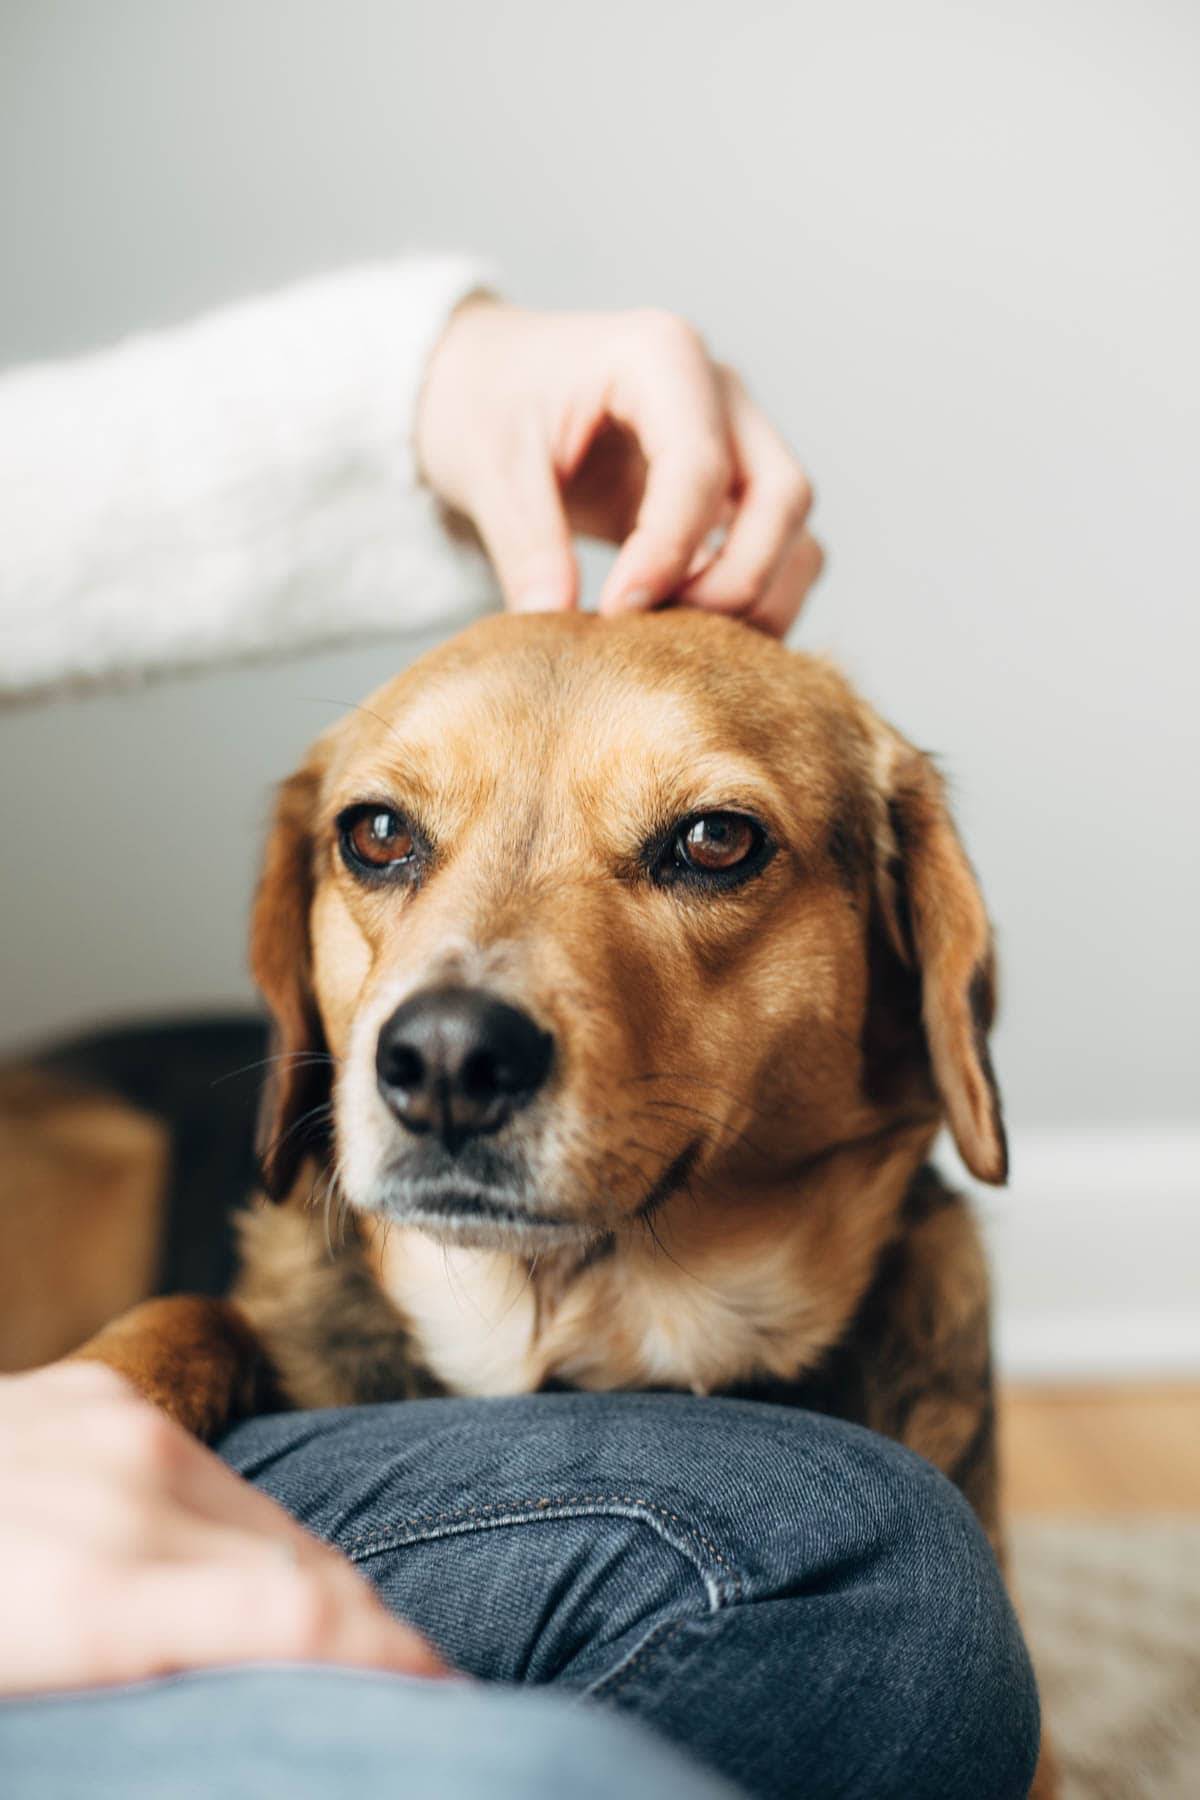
471, 452, 579, 612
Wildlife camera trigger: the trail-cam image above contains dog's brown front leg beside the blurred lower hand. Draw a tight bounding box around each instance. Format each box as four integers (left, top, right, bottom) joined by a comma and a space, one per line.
67, 1294, 273, 1442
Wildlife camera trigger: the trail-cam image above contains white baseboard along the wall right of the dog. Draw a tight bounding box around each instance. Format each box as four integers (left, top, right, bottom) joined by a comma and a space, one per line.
949, 1125, 1200, 1382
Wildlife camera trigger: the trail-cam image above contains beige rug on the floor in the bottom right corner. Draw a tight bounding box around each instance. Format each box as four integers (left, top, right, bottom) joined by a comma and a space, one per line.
1011, 1517, 1200, 1800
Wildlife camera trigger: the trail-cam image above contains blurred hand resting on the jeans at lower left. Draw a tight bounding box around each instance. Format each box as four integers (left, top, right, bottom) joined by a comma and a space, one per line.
0, 1363, 450, 1694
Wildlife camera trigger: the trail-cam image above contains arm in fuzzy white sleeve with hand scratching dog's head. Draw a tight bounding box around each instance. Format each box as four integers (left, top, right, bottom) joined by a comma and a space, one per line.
0, 257, 822, 700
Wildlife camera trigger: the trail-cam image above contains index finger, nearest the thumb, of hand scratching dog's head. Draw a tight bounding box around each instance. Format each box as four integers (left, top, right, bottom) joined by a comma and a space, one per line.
599, 320, 734, 612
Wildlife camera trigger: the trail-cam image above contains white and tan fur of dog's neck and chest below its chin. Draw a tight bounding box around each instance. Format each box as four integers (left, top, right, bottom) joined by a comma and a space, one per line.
237, 1145, 914, 1406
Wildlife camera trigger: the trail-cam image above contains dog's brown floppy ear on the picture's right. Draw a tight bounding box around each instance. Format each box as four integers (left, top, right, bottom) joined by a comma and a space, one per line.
878, 733, 1007, 1184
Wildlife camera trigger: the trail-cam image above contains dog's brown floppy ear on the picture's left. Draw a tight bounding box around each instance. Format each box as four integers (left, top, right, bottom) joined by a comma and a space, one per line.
250, 765, 331, 1201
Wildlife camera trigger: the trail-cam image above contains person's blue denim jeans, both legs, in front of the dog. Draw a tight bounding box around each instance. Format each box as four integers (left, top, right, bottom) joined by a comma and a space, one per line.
0, 1393, 1038, 1800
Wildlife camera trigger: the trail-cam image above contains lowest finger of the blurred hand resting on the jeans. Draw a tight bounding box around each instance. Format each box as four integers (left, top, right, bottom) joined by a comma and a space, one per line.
126, 1561, 450, 1678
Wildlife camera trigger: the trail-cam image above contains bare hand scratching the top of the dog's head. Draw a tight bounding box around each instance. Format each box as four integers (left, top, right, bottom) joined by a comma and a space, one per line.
416, 299, 822, 635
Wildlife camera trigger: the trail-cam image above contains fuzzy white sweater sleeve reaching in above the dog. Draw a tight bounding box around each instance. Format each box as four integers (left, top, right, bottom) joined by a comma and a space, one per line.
0, 257, 497, 697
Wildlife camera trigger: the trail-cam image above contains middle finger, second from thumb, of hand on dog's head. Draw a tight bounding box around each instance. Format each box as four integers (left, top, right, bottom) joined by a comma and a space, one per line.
682, 371, 813, 612
